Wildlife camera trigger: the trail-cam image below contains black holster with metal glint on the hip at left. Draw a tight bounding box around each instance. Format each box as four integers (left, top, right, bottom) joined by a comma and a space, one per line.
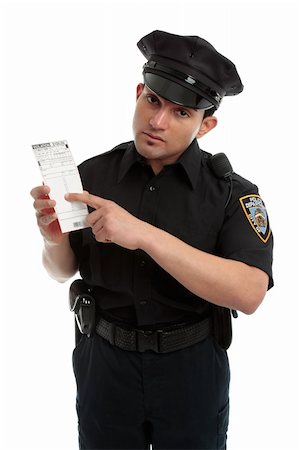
69, 279, 96, 344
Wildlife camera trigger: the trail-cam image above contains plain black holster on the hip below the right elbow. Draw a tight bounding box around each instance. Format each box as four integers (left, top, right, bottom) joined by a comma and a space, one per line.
211, 304, 238, 350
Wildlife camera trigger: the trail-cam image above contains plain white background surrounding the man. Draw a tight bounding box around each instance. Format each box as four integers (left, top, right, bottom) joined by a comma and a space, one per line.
0, 0, 299, 450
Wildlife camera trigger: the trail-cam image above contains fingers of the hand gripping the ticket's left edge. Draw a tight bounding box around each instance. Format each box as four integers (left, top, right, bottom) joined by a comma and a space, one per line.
30, 186, 64, 245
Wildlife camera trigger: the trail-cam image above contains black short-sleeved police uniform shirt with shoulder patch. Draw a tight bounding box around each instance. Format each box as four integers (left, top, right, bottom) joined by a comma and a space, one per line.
70, 140, 273, 326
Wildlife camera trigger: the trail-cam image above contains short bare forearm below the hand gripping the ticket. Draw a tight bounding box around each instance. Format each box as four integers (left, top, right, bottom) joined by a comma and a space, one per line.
43, 235, 78, 283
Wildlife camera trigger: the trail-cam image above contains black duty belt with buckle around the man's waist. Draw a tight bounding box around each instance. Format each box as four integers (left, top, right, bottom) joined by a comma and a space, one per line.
95, 318, 210, 353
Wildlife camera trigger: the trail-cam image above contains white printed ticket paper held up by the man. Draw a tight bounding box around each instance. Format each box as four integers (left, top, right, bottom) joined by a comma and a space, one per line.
32, 141, 88, 233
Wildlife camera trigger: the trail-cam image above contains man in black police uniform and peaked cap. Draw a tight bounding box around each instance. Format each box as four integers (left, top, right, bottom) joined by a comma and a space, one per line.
32, 31, 273, 450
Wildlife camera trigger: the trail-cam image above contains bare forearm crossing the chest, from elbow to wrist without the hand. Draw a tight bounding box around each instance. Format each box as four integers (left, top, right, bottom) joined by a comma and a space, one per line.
141, 225, 268, 314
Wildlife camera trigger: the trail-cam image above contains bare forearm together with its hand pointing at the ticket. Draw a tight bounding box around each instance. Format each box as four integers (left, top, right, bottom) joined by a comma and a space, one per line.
63, 192, 268, 314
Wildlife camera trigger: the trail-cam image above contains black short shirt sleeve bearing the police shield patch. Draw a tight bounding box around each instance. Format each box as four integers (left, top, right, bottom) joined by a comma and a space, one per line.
217, 178, 274, 289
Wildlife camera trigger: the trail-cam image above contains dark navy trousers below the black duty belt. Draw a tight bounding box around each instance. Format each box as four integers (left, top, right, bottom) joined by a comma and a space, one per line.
73, 335, 230, 450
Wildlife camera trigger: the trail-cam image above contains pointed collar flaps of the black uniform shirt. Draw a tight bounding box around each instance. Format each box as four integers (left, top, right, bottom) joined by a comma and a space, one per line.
118, 139, 202, 189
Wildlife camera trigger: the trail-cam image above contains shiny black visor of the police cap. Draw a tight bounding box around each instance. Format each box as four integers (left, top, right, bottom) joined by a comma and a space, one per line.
144, 72, 215, 109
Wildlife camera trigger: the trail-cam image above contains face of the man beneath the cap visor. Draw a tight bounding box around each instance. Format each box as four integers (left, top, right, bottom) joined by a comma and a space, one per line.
133, 84, 209, 169
